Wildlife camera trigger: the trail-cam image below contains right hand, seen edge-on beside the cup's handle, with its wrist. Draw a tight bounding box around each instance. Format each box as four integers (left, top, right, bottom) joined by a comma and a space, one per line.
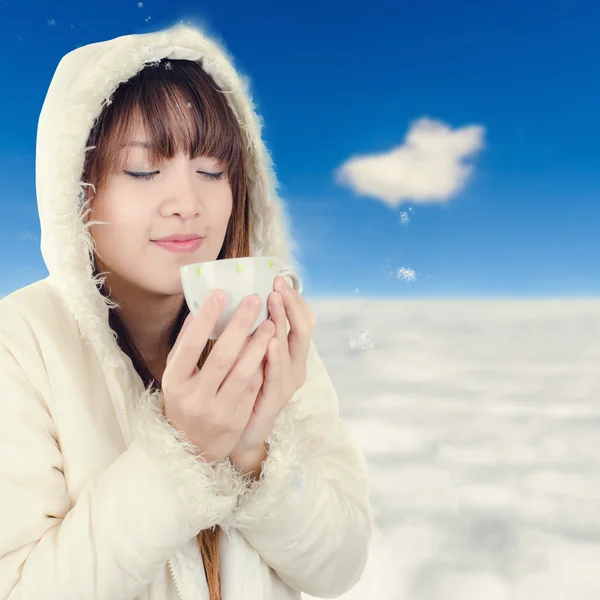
230, 277, 316, 464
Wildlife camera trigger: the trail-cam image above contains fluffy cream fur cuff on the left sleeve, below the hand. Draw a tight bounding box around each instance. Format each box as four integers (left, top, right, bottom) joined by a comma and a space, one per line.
131, 382, 245, 531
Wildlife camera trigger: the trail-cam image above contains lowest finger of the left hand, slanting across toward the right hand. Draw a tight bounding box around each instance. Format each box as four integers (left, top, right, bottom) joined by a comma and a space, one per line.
216, 319, 275, 413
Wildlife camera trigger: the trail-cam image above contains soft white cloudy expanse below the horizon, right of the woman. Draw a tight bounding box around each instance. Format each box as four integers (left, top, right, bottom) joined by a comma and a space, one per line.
302, 298, 600, 600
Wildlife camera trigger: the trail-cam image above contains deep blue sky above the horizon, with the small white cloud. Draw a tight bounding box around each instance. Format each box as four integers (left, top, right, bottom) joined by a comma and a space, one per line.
0, 0, 600, 297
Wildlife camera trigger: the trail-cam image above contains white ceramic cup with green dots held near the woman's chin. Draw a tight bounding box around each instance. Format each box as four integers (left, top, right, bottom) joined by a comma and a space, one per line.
180, 256, 302, 340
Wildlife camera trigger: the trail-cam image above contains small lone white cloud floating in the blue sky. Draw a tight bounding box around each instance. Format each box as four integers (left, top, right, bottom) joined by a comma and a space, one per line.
336, 117, 484, 208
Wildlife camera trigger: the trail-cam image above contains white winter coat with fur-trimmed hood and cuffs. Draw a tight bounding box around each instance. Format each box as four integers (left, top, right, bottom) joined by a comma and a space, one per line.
0, 25, 372, 600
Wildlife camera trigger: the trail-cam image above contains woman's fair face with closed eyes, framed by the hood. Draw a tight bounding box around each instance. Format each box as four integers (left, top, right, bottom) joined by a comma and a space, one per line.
90, 130, 233, 302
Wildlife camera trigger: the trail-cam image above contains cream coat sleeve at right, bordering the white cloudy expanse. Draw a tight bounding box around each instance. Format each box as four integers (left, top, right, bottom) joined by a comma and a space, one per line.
227, 340, 373, 598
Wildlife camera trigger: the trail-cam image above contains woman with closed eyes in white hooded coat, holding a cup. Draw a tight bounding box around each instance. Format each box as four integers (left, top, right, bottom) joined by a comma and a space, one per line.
0, 25, 372, 600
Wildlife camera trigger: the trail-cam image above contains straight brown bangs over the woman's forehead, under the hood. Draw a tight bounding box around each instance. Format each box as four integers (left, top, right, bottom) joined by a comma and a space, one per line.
89, 59, 244, 187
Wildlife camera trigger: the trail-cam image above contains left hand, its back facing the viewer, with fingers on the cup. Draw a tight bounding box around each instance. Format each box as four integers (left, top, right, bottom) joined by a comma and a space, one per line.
162, 290, 275, 463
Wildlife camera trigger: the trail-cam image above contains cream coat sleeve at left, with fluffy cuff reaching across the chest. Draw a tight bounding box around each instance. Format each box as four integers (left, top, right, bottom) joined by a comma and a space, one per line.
0, 328, 243, 600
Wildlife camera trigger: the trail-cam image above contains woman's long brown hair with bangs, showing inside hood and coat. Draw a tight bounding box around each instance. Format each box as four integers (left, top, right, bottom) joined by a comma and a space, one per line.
83, 59, 250, 600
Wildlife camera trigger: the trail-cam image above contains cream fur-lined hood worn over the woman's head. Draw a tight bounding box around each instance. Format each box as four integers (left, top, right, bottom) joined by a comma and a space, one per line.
36, 25, 300, 366
